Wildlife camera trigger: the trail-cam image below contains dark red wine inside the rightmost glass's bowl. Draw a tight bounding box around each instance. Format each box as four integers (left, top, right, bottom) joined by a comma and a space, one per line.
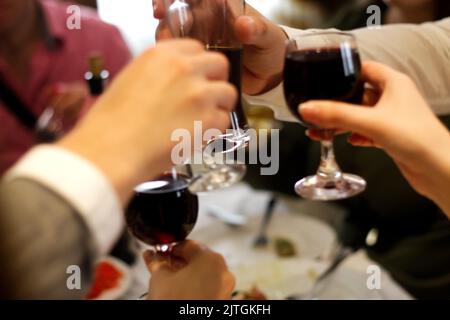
284, 48, 364, 127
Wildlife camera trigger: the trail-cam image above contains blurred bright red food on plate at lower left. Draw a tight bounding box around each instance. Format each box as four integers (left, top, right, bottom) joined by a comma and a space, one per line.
87, 261, 124, 300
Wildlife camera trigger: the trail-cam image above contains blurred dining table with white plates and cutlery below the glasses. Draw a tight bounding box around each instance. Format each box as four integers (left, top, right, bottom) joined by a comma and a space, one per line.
122, 183, 412, 300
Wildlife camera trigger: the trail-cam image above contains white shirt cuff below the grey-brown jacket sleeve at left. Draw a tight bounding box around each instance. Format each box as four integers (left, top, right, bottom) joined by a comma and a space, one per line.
4, 145, 124, 255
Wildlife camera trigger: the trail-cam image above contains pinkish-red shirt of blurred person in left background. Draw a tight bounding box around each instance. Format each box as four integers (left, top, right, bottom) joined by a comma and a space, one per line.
0, 0, 131, 176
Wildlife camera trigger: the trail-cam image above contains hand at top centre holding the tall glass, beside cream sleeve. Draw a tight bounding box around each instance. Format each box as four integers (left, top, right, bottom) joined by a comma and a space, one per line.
153, 0, 287, 95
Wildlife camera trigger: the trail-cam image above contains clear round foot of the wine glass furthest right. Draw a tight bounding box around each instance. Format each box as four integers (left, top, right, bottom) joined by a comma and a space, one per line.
295, 173, 366, 201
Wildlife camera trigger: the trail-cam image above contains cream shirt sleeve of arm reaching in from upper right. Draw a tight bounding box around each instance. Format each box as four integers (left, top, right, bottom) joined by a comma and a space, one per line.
244, 18, 450, 122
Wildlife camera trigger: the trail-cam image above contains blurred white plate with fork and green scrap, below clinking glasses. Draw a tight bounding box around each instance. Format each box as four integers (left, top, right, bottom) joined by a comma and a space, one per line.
190, 211, 335, 299
